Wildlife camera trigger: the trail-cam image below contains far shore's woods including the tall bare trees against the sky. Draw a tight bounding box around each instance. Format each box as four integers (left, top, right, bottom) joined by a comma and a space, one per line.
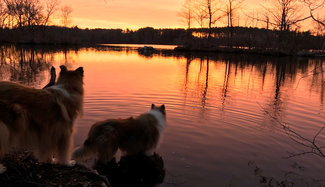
0, 0, 325, 55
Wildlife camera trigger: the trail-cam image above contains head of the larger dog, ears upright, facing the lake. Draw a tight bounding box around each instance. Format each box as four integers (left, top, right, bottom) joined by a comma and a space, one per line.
56, 65, 84, 93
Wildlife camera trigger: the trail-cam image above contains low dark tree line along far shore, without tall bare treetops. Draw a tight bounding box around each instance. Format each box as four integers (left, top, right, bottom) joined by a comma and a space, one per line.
0, 26, 325, 55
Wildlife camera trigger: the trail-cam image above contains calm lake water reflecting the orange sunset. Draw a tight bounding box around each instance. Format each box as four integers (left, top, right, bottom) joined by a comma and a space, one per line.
0, 46, 325, 187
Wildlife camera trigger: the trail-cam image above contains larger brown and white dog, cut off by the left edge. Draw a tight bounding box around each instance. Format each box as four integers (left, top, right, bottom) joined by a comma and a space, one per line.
0, 66, 84, 173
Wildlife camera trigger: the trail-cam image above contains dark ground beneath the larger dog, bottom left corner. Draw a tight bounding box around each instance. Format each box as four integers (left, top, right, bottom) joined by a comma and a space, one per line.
0, 151, 109, 187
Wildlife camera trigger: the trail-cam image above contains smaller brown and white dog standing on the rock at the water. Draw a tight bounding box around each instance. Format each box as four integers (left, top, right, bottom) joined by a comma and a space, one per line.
72, 104, 166, 164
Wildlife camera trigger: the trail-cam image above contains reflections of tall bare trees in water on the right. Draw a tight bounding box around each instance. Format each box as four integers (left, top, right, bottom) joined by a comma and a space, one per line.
178, 51, 325, 114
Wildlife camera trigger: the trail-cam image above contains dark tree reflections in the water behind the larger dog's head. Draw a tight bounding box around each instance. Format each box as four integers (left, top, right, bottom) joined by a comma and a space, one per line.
0, 45, 80, 87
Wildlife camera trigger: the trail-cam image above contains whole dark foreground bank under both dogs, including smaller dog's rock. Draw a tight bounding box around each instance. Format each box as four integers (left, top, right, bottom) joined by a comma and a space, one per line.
0, 151, 165, 187
